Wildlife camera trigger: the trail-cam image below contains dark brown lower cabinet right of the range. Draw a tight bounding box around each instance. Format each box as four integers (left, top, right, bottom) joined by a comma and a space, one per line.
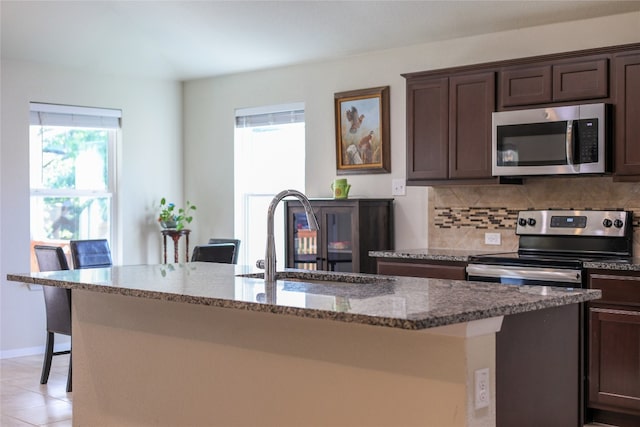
587, 270, 640, 427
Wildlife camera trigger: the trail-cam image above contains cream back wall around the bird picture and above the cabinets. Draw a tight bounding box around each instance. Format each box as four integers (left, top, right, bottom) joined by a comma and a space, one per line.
184, 13, 640, 254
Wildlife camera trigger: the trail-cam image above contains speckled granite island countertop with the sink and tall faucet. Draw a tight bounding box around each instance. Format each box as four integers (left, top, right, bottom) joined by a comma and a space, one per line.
7, 262, 601, 330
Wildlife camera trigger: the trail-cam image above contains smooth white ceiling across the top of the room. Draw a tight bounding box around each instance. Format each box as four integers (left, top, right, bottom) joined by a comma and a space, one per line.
0, 0, 640, 80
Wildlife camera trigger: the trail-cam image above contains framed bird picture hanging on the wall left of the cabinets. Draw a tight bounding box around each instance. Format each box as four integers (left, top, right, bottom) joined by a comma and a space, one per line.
334, 86, 391, 175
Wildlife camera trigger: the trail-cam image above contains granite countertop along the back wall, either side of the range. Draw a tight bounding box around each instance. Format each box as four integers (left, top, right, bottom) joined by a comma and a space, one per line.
369, 249, 640, 271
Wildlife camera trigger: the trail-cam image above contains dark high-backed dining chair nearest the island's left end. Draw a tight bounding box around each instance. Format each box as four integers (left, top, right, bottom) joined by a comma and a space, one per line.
34, 245, 71, 392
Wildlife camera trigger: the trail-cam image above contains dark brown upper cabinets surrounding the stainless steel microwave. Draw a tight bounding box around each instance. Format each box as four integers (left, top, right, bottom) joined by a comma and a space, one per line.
402, 43, 640, 185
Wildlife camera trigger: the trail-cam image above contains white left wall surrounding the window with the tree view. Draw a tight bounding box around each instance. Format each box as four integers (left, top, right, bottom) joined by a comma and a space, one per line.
0, 60, 183, 357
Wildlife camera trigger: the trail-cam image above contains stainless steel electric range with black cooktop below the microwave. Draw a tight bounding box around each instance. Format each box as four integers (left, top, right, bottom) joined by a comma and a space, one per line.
467, 210, 633, 288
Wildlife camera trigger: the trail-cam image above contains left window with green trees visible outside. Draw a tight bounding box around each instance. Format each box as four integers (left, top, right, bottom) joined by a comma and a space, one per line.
29, 103, 121, 270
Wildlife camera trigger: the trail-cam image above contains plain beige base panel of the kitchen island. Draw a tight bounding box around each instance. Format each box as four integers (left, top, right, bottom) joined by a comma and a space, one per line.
72, 290, 501, 427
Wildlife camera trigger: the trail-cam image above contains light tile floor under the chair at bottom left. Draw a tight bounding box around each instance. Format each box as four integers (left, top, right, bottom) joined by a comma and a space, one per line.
0, 355, 73, 427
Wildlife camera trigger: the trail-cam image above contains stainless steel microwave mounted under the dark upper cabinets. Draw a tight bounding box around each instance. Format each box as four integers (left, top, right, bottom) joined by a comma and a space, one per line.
492, 104, 609, 176
